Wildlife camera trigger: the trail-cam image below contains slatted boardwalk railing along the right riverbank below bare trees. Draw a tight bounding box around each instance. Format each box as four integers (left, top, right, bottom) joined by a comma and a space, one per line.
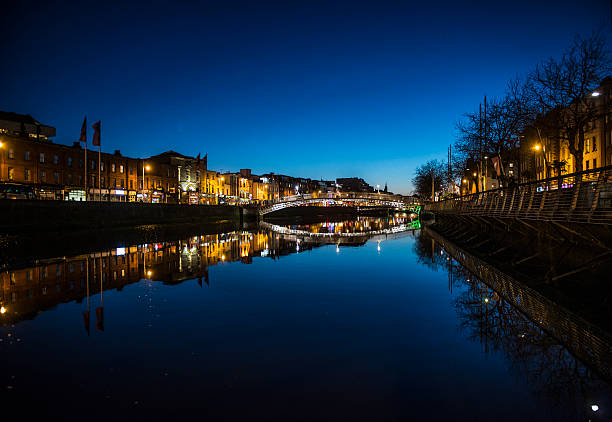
425, 166, 612, 224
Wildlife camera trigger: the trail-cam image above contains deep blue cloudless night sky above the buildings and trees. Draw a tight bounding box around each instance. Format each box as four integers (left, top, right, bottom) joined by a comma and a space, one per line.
0, 0, 611, 193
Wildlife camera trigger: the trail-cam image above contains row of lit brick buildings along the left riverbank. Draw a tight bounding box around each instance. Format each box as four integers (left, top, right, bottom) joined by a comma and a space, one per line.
0, 111, 374, 204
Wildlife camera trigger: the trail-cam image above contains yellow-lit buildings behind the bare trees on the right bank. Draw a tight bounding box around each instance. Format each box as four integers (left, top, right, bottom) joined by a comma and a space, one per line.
460, 77, 612, 194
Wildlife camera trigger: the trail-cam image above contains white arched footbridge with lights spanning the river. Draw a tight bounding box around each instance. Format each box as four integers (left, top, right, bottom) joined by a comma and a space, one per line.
258, 192, 421, 216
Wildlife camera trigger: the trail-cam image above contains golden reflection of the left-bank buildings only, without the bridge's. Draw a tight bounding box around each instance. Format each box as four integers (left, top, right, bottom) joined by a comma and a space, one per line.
0, 231, 326, 325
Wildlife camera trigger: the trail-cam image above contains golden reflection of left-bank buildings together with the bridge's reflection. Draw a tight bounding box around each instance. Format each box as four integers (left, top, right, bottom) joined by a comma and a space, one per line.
0, 215, 420, 325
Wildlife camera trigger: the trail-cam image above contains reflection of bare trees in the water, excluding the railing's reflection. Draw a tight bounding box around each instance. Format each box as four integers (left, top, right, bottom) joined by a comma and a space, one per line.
414, 233, 612, 420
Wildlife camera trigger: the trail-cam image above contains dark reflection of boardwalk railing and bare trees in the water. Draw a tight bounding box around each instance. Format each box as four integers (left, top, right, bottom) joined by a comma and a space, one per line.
415, 228, 612, 420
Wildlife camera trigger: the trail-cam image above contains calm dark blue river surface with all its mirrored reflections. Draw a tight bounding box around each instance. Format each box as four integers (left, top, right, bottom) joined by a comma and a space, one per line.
0, 215, 612, 421
